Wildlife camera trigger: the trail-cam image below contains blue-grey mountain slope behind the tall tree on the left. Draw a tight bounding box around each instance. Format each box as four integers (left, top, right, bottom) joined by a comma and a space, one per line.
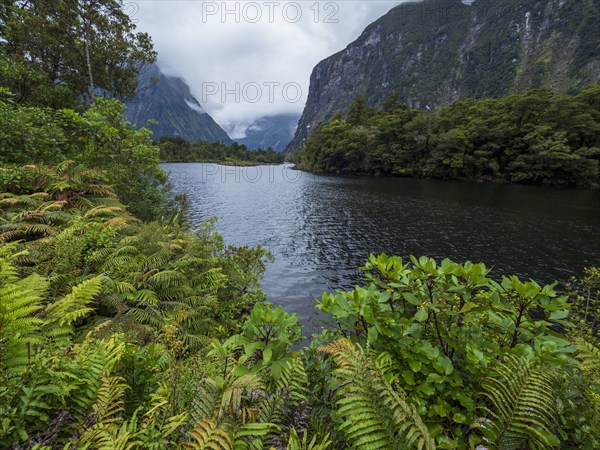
126, 65, 231, 143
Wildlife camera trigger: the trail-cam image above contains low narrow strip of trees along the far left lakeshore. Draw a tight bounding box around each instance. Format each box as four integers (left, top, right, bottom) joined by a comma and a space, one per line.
158, 136, 285, 164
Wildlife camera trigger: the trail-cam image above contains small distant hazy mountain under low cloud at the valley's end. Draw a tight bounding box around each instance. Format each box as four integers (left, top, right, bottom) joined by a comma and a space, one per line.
235, 114, 300, 152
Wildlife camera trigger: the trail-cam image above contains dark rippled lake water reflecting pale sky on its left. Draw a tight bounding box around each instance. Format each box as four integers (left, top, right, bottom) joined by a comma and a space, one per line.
163, 163, 600, 328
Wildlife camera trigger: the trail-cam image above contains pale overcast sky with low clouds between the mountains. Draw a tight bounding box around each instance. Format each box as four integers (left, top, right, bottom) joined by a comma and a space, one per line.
134, 0, 402, 138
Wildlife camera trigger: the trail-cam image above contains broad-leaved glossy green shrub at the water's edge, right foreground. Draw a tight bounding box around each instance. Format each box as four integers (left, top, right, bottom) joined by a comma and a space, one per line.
317, 255, 592, 448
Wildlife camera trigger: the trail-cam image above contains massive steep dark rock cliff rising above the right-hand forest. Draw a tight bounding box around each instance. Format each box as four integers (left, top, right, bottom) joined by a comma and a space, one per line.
288, 0, 600, 150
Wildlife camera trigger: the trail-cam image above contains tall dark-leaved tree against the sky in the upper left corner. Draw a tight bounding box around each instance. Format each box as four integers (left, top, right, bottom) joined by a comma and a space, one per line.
0, 0, 156, 106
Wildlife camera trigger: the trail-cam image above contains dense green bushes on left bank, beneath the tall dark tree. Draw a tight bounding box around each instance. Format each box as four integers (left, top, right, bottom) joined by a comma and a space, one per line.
0, 99, 167, 219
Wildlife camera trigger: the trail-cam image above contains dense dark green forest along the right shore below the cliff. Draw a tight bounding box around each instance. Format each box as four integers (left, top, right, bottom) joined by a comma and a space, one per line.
293, 84, 600, 186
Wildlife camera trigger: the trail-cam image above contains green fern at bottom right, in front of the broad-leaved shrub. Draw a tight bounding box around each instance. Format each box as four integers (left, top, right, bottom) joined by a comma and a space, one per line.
476, 356, 559, 450
